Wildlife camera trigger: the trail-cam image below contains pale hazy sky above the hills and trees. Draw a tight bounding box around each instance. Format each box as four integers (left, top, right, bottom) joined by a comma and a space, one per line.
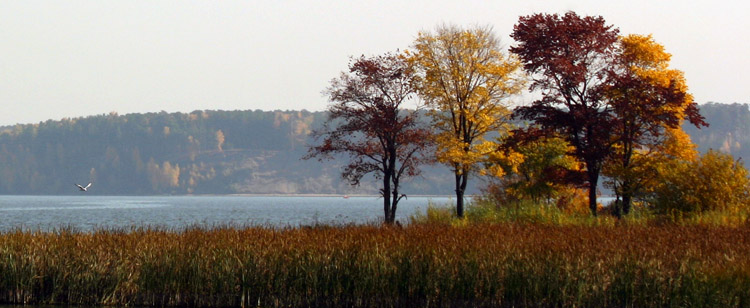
0, 0, 750, 125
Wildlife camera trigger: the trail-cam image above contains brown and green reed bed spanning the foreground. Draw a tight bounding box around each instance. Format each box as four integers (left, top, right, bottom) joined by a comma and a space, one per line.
0, 223, 750, 307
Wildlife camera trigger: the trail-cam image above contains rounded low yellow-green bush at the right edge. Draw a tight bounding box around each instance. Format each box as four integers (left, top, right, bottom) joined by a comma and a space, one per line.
649, 150, 750, 215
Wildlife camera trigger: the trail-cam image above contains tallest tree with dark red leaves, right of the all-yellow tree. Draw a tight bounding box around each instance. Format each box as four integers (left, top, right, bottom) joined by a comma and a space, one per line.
510, 12, 618, 215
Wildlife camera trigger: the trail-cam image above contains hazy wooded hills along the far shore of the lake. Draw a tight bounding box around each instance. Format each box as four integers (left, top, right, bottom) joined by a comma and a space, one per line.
0, 103, 750, 195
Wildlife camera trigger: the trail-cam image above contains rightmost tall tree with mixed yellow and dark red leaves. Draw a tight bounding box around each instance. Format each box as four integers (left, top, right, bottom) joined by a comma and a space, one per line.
605, 35, 708, 215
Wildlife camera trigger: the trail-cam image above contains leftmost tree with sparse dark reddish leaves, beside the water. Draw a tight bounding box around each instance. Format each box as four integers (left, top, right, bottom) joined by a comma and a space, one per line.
306, 54, 431, 223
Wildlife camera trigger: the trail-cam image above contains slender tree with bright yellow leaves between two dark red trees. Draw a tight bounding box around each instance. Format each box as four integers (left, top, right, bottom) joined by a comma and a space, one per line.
411, 26, 525, 217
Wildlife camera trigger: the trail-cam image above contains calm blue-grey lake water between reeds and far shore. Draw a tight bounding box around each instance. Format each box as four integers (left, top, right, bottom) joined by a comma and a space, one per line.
0, 195, 451, 231
